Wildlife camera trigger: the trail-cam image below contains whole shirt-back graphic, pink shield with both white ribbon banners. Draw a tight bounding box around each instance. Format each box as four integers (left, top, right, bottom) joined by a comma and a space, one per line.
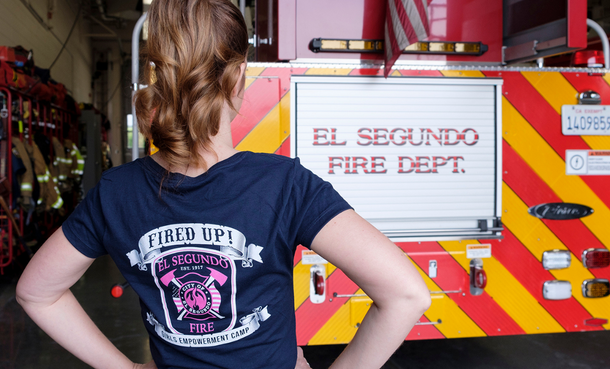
127, 223, 270, 347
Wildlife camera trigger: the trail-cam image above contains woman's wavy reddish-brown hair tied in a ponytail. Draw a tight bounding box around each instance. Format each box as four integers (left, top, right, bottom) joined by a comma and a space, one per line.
134, 0, 248, 168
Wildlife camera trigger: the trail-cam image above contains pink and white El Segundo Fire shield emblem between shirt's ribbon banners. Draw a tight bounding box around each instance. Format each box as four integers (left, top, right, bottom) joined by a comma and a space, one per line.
152, 247, 236, 334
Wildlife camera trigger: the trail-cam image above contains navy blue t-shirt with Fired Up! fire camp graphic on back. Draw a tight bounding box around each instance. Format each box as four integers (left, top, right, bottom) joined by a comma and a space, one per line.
63, 152, 350, 369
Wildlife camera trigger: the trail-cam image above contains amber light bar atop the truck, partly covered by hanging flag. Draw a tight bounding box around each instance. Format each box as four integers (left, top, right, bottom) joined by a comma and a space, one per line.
309, 38, 488, 55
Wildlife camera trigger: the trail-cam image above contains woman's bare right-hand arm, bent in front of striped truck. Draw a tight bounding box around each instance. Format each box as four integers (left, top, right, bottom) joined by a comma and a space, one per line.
311, 210, 430, 369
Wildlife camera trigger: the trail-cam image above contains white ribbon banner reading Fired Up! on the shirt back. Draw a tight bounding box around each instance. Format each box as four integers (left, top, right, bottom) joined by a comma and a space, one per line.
127, 223, 263, 270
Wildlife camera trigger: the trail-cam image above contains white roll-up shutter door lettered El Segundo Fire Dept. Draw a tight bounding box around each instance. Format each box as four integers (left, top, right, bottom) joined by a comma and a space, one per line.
291, 76, 502, 240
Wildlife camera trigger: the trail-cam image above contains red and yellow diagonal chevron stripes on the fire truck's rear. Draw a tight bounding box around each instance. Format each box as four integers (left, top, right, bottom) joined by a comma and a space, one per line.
240, 66, 610, 345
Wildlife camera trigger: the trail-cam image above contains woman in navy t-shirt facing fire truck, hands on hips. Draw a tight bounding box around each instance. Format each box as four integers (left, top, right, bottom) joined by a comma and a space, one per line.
17, 0, 430, 369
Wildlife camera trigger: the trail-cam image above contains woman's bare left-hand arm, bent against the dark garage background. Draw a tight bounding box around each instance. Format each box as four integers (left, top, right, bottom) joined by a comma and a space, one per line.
17, 228, 154, 369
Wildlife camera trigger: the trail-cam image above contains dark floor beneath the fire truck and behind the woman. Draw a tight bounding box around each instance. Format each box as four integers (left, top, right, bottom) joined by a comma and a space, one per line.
0, 257, 610, 369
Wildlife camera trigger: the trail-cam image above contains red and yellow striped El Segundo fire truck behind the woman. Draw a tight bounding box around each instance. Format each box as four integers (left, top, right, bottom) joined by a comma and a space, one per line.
134, 0, 610, 345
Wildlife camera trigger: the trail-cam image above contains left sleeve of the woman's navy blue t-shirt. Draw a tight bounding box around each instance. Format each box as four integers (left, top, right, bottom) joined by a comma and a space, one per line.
62, 180, 107, 258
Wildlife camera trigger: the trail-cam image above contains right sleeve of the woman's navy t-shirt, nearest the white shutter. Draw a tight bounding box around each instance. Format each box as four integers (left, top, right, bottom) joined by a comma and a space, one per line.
290, 158, 352, 248
